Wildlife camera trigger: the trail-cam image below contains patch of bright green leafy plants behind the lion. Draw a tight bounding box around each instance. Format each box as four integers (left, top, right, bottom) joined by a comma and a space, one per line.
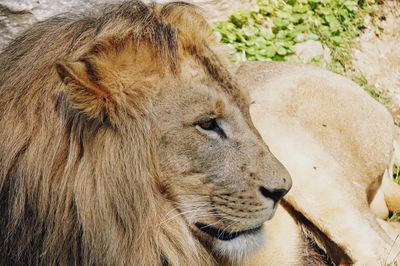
215, 0, 379, 73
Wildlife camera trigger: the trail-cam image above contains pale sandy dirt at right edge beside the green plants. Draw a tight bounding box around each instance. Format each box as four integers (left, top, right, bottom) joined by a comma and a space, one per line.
353, 0, 400, 125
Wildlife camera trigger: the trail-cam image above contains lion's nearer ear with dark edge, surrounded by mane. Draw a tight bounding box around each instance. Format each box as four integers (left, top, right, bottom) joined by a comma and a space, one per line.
55, 59, 112, 121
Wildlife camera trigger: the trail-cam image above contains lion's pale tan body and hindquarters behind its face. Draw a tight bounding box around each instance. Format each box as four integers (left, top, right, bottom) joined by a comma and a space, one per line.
237, 63, 400, 265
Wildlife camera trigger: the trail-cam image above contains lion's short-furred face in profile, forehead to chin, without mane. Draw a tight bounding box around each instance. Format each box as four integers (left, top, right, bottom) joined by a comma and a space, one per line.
156, 59, 291, 259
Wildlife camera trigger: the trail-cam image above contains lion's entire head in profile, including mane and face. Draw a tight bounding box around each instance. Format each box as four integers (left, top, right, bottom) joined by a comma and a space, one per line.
0, 1, 291, 265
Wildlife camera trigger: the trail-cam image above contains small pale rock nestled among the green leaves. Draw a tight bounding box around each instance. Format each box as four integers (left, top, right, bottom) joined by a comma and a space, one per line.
294, 40, 331, 64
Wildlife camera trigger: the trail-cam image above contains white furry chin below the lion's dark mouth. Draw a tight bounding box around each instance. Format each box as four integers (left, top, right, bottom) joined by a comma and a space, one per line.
212, 227, 266, 264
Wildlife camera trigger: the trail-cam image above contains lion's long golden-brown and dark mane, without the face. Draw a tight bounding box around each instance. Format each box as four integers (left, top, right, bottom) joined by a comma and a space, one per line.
0, 1, 223, 265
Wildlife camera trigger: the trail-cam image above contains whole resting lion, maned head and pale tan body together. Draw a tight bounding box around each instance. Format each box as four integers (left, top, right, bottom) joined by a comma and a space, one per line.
0, 1, 399, 265
